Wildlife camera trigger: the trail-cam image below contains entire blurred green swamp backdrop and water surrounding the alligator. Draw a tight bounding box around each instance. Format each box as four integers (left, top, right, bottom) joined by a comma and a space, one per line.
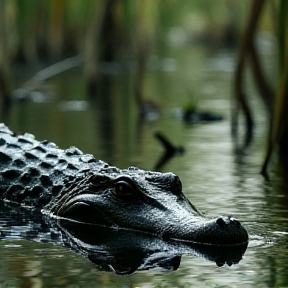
0, 0, 288, 287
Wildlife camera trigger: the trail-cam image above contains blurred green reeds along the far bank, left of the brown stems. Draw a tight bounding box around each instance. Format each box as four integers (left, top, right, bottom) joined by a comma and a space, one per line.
0, 0, 246, 98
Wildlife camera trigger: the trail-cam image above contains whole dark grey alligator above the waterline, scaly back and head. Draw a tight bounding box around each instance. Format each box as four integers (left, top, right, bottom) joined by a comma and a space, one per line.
0, 124, 248, 245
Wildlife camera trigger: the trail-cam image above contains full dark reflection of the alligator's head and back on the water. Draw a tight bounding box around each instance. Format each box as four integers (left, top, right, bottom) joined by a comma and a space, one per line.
0, 204, 247, 275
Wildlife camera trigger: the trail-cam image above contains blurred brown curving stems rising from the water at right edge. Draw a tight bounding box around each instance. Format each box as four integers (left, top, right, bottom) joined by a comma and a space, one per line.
232, 0, 288, 179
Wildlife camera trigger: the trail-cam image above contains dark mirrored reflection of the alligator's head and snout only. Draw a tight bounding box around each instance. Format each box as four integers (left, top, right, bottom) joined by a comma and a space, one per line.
60, 221, 247, 274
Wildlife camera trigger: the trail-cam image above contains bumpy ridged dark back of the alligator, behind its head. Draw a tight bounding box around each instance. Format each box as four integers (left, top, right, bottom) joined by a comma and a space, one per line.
0, 123, 107, 208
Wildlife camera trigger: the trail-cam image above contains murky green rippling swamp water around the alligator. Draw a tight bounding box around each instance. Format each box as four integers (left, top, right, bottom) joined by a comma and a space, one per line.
0, 48, 288, 287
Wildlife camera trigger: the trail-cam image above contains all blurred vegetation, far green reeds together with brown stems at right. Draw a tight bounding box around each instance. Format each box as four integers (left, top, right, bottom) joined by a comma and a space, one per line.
0, 0, 288, 174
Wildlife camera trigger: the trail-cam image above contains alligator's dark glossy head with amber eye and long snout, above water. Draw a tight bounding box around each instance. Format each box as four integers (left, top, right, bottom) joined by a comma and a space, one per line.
44, 165, 248, 245
